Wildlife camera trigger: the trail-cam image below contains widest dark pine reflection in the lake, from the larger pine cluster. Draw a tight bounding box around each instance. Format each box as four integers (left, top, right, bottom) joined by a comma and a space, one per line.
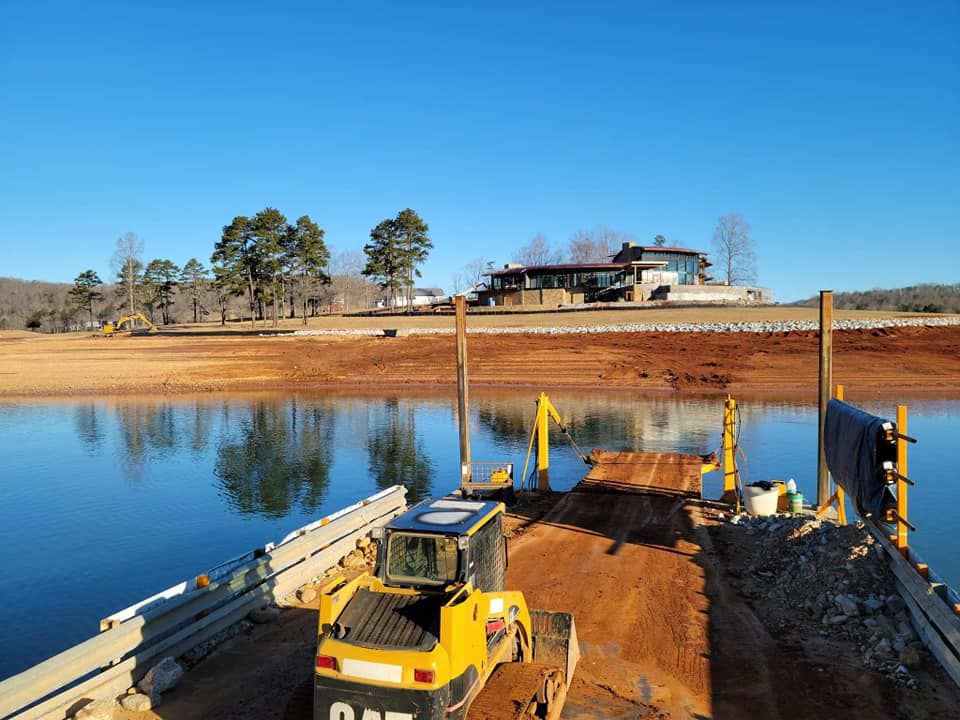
214, 399, 334, 519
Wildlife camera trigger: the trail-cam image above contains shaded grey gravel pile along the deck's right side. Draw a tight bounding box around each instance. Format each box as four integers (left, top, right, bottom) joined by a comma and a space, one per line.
728, 514, 926, 688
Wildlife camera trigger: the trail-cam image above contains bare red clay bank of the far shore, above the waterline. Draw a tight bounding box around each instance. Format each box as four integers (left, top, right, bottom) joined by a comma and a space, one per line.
0, 327, 960, 397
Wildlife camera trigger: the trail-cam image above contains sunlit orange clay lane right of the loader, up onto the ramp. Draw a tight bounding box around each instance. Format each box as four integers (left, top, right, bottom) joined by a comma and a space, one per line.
507, 450, 711, 718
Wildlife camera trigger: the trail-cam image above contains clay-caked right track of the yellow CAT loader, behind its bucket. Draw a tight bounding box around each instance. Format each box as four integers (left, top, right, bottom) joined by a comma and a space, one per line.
467, 662, 567, 720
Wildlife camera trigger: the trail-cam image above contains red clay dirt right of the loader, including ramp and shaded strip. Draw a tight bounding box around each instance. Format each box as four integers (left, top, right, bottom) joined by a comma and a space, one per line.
508, 451, 960, 720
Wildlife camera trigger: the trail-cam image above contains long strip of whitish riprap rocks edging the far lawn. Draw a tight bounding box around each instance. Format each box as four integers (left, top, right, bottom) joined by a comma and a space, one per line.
293, 317, 960, 337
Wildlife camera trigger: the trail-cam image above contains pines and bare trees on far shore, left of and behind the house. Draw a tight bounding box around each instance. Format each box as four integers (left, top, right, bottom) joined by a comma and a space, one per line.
0, 207, 756, 331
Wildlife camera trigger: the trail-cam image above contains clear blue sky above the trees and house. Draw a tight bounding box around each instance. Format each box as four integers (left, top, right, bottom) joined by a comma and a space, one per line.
0, 2, 960, 300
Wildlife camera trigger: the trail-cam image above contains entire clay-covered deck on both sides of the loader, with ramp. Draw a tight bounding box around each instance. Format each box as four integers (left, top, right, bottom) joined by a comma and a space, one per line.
99, 450, 960, 720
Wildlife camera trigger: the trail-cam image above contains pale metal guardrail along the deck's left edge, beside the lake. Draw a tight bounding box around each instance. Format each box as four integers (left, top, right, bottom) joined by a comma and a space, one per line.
0, 485, 406, 720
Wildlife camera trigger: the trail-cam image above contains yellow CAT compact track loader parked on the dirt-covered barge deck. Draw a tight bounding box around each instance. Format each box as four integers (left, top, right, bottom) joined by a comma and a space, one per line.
314, 498, 579, 720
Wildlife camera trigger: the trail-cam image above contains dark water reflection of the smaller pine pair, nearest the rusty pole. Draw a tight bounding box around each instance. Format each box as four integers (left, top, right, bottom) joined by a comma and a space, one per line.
367, 397, 433, 503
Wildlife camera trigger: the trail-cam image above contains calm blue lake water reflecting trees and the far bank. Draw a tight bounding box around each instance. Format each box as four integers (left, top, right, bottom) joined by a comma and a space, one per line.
0, 391, 960, 678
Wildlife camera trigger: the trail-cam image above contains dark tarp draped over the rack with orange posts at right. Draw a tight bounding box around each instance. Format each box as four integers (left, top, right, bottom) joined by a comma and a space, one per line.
823, 400, 897, 519
